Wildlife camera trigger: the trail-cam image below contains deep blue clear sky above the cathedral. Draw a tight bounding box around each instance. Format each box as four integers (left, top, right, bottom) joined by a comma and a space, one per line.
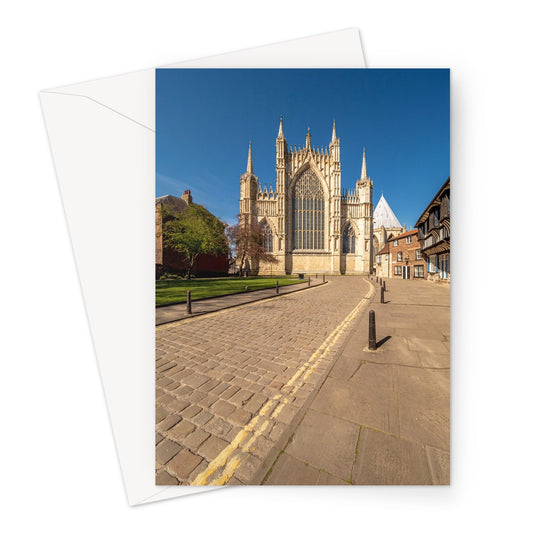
156, 69, 450, 228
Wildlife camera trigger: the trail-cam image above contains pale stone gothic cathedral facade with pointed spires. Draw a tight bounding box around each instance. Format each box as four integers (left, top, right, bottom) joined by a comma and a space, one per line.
239, 118, 373, 275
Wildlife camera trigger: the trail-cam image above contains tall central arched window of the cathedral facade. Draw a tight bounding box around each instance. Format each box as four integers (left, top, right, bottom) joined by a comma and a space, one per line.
292, 169, 324, 250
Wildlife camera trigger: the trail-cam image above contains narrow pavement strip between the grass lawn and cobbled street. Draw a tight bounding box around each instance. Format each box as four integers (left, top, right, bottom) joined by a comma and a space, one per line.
155, 274, 323, 326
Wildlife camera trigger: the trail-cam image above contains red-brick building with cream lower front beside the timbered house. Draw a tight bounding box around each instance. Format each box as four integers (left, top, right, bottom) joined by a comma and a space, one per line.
375, 229, 427, 279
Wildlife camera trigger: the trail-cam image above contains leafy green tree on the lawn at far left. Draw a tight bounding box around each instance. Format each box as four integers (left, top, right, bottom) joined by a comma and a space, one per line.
161, 204, 228, 279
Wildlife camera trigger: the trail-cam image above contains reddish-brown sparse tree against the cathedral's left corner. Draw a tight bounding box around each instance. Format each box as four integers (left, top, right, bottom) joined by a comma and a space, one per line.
226, 217, 278, 276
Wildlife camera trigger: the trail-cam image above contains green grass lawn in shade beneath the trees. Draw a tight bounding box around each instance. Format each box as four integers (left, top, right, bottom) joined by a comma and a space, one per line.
155, 277, 307, 306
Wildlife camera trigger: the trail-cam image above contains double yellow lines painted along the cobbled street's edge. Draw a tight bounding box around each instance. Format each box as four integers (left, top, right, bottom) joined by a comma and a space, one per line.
191, 279, 376, 485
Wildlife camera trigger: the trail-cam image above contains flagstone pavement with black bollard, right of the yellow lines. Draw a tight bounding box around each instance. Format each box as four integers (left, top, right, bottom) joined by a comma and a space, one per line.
264, 279, 450, 485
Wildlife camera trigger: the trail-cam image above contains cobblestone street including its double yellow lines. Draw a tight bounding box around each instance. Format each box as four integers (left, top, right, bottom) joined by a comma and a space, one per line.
156, 277, 375, 485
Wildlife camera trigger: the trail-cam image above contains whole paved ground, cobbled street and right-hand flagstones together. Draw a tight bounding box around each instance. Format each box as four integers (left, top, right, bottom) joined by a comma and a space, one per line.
156, 277, 449, 485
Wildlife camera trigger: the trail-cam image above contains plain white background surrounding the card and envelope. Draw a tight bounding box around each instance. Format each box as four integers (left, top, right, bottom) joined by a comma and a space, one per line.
0, 0, 533, 532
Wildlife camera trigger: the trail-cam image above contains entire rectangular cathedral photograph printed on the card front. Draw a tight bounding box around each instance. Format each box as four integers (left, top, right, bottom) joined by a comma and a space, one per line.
154, 68, 451, 485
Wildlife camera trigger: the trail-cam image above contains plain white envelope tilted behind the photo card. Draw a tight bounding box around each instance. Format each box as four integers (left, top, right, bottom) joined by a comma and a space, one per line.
40, 28, 365, 505
